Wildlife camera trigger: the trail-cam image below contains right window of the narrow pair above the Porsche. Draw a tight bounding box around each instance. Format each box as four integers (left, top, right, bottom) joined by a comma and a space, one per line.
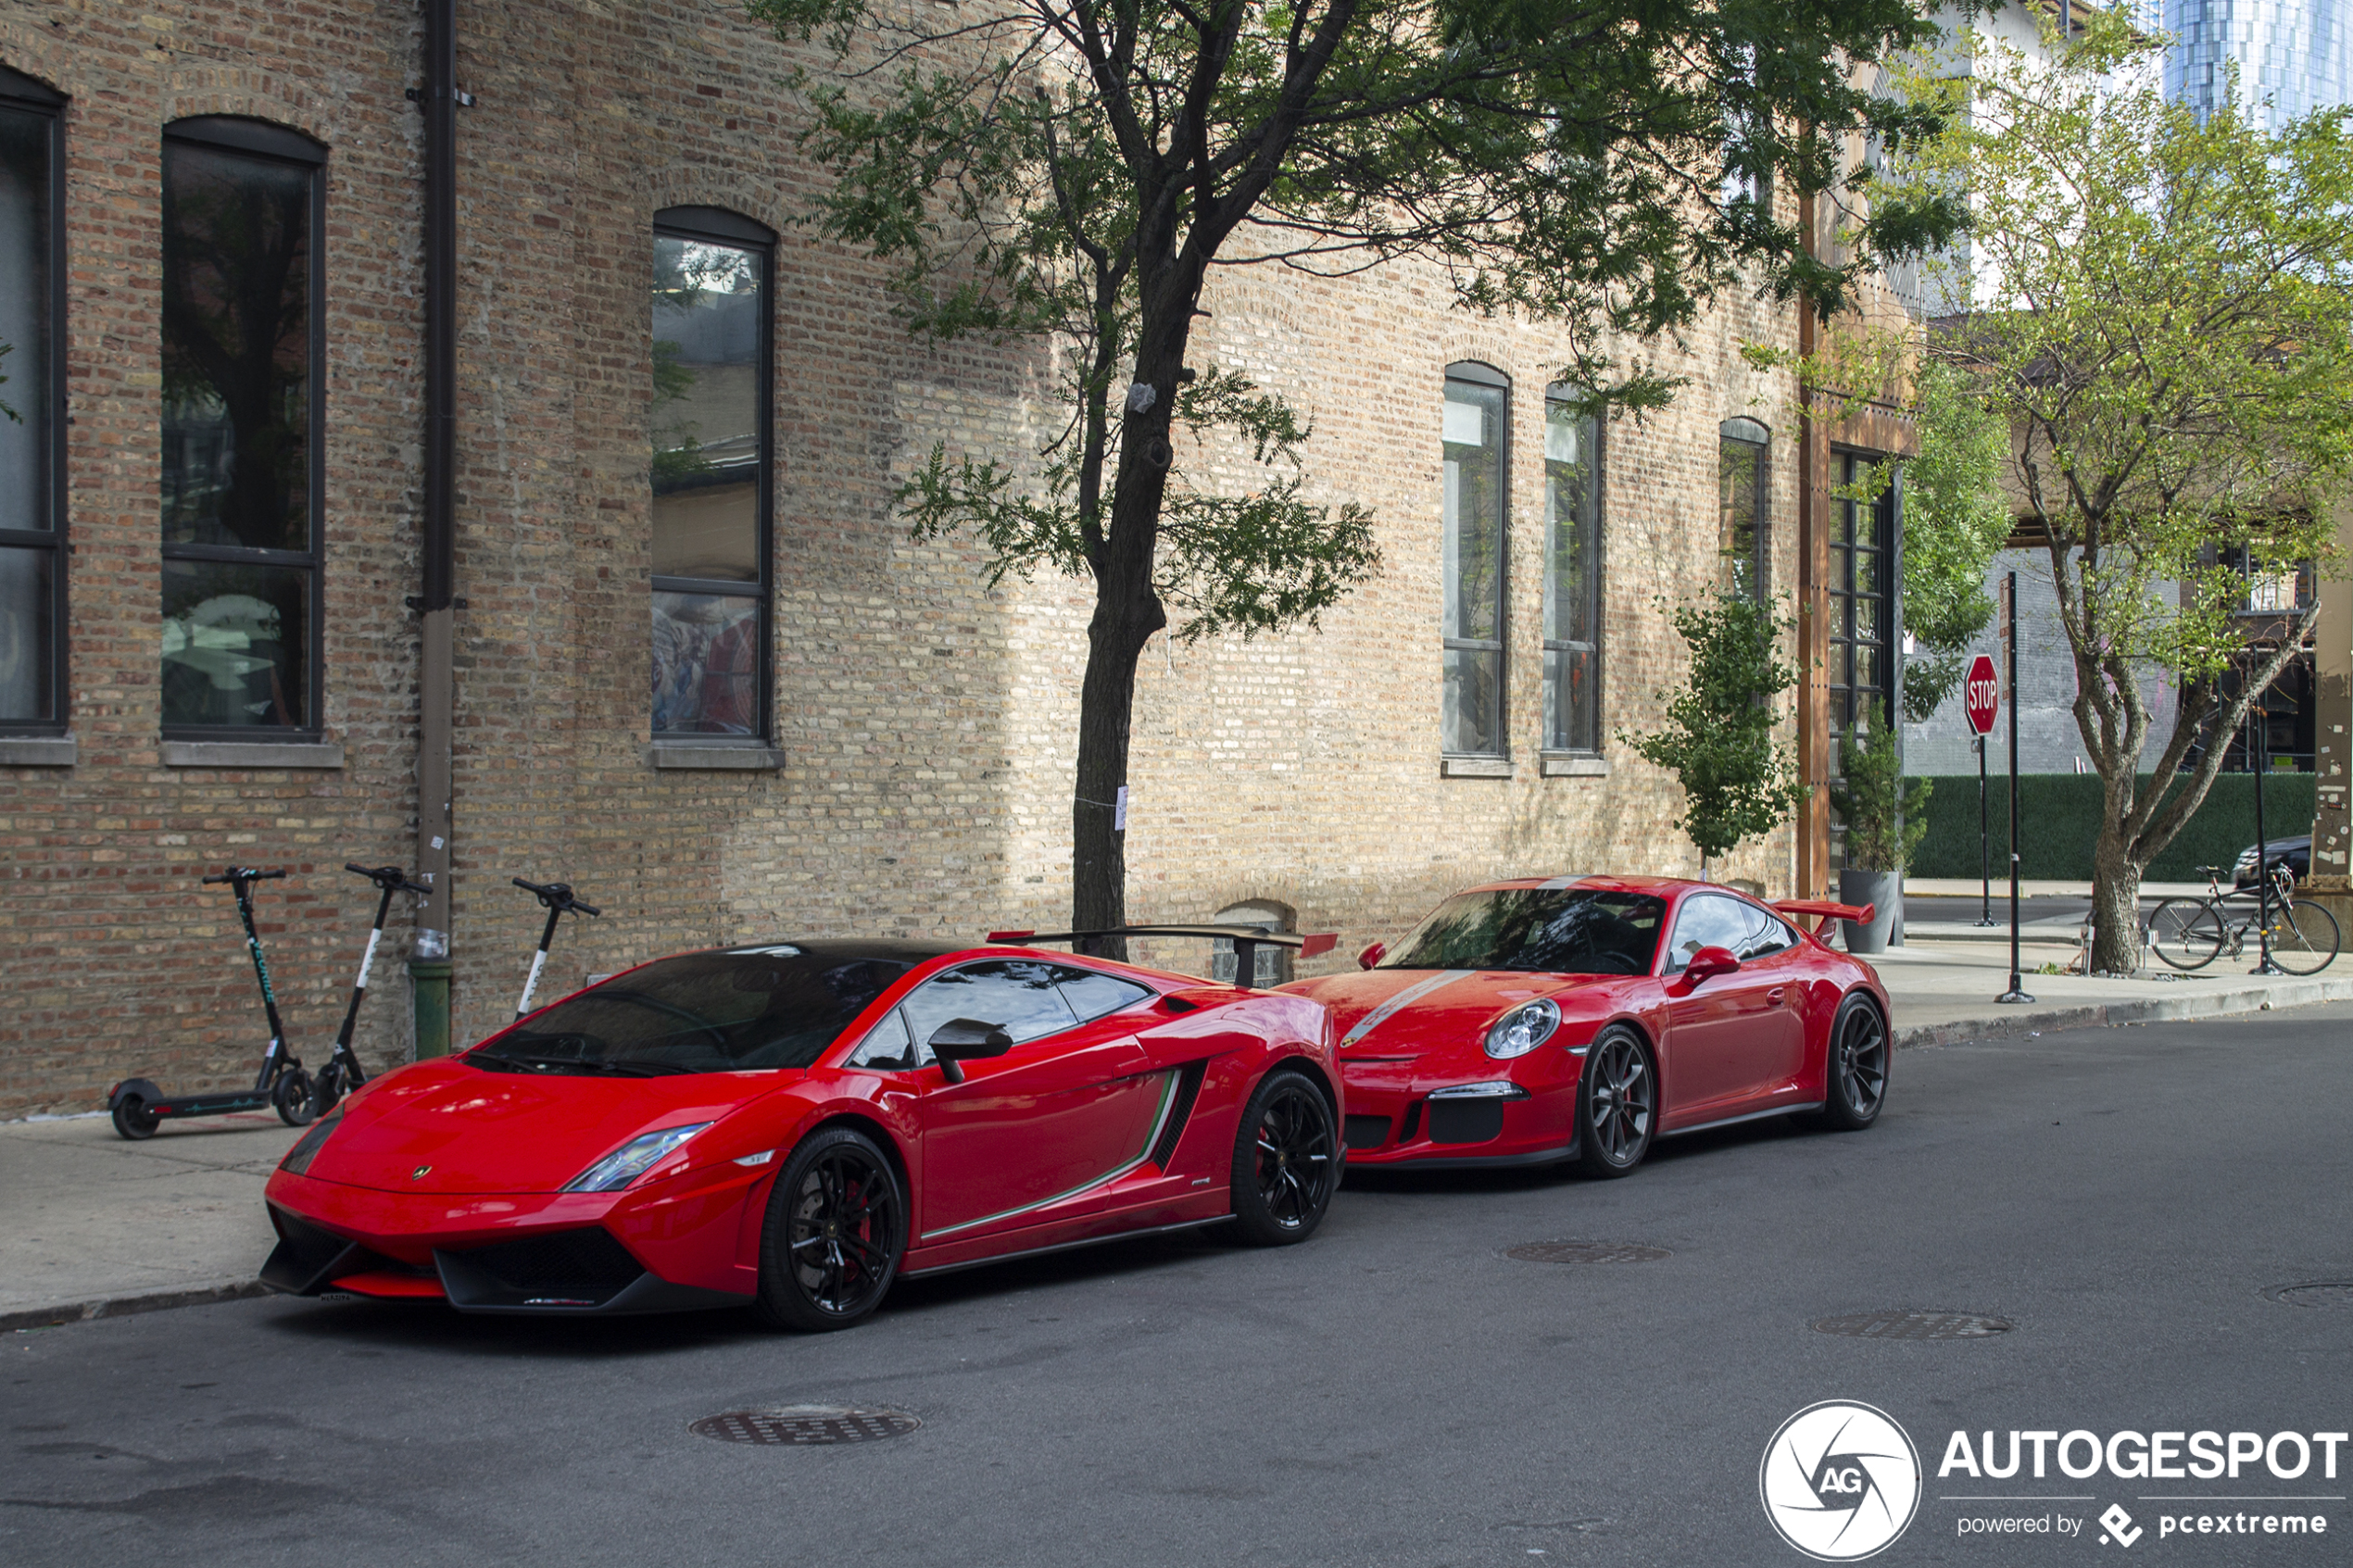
1543, 383, 1603, 755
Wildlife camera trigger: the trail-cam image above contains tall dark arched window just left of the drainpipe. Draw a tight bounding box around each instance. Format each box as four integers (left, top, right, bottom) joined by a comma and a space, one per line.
162, 118, 327, 734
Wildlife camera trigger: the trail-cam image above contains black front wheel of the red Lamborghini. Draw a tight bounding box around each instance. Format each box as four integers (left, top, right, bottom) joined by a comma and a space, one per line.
753, 1126, 906, 1333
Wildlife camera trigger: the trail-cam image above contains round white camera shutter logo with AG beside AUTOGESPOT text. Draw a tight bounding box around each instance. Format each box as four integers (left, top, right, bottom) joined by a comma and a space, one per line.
1757, 1399, 1920, 1563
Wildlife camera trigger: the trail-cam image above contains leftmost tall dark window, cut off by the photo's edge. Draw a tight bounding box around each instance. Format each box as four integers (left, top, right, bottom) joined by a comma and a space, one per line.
0, 69, 66, 734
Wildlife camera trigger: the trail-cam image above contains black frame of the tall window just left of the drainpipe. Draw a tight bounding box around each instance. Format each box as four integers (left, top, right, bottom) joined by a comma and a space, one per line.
156, 115, 327, 743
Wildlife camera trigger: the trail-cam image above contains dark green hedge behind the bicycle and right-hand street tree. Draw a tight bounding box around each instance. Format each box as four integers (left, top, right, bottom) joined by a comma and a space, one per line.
1910, 773, 2315, 882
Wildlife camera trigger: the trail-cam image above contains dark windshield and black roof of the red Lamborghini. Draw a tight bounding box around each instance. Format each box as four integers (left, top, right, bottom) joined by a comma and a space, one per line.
466, 943, 929, 1077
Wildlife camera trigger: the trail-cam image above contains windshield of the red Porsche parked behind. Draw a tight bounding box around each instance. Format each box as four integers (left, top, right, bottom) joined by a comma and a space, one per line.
1381, 888, 1666, 975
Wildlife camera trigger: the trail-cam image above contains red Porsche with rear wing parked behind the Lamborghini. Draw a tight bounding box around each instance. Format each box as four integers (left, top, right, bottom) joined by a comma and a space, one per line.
1282, 877, 1890, 1175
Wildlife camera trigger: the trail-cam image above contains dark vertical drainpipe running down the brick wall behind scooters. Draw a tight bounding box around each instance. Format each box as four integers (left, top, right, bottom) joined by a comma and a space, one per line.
409, 0, 459, 1058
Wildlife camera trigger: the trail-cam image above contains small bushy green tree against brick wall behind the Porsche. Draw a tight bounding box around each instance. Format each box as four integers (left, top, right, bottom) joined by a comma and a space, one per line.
1619, 588, 1805, 877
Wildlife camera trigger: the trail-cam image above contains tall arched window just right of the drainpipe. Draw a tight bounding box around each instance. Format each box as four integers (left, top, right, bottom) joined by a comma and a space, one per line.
649, 207, 776, 741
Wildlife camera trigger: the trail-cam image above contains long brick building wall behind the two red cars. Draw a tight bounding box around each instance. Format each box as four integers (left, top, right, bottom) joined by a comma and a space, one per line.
0, 0, 1901, 1117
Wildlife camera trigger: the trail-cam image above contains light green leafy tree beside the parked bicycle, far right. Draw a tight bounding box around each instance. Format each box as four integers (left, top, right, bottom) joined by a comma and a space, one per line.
1892, 17, 2353, 971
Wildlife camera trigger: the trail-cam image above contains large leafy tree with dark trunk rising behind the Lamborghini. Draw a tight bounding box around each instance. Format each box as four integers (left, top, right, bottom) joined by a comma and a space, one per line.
749, 0, 1960, 945
